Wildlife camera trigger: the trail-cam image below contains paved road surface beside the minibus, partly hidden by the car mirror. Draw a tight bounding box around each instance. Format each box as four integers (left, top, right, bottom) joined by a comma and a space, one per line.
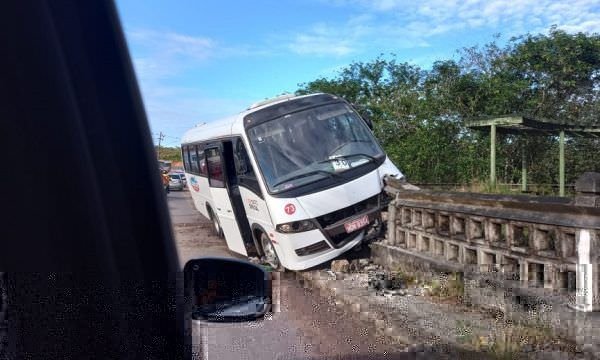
168, 191, 415, 360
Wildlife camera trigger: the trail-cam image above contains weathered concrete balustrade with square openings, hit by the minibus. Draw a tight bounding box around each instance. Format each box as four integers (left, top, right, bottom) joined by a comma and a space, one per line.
385, 173, 600, 312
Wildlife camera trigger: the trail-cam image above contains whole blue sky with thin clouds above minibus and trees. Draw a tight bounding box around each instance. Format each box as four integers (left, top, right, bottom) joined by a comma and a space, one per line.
116, 0, 600, 146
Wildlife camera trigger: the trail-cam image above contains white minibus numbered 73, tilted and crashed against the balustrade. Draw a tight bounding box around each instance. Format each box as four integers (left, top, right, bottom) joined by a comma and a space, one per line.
181, 93, 402, 270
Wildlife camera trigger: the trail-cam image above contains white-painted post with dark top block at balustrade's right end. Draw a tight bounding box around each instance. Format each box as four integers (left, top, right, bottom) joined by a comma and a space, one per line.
575, 173, 600, 312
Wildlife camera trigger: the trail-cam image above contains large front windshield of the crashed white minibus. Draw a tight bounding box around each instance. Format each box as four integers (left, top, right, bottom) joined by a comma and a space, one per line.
248, 103, 385, 193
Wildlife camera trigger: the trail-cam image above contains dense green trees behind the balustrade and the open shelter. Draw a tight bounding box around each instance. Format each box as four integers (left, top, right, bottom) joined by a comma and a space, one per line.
298, 28, 600, 188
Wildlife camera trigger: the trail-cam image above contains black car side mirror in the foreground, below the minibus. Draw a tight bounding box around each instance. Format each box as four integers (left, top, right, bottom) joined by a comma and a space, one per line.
183, 257, 271, 321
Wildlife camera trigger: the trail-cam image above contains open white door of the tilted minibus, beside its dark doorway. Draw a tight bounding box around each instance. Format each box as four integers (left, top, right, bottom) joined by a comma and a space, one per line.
205, 145, 248, 255
